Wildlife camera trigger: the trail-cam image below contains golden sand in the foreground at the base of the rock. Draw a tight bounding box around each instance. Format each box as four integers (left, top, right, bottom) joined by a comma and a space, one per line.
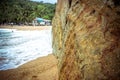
0, 54, 58, 80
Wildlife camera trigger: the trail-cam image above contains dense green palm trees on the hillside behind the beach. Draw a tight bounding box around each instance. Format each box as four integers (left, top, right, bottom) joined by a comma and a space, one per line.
0, 0, 55, 24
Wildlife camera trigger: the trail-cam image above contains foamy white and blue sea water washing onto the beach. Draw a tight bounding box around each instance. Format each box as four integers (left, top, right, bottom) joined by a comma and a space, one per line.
0, 29, 52, 70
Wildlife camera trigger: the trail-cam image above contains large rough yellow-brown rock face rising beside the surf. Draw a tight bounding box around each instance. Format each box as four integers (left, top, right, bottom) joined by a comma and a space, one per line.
53, 0, 120, 80
